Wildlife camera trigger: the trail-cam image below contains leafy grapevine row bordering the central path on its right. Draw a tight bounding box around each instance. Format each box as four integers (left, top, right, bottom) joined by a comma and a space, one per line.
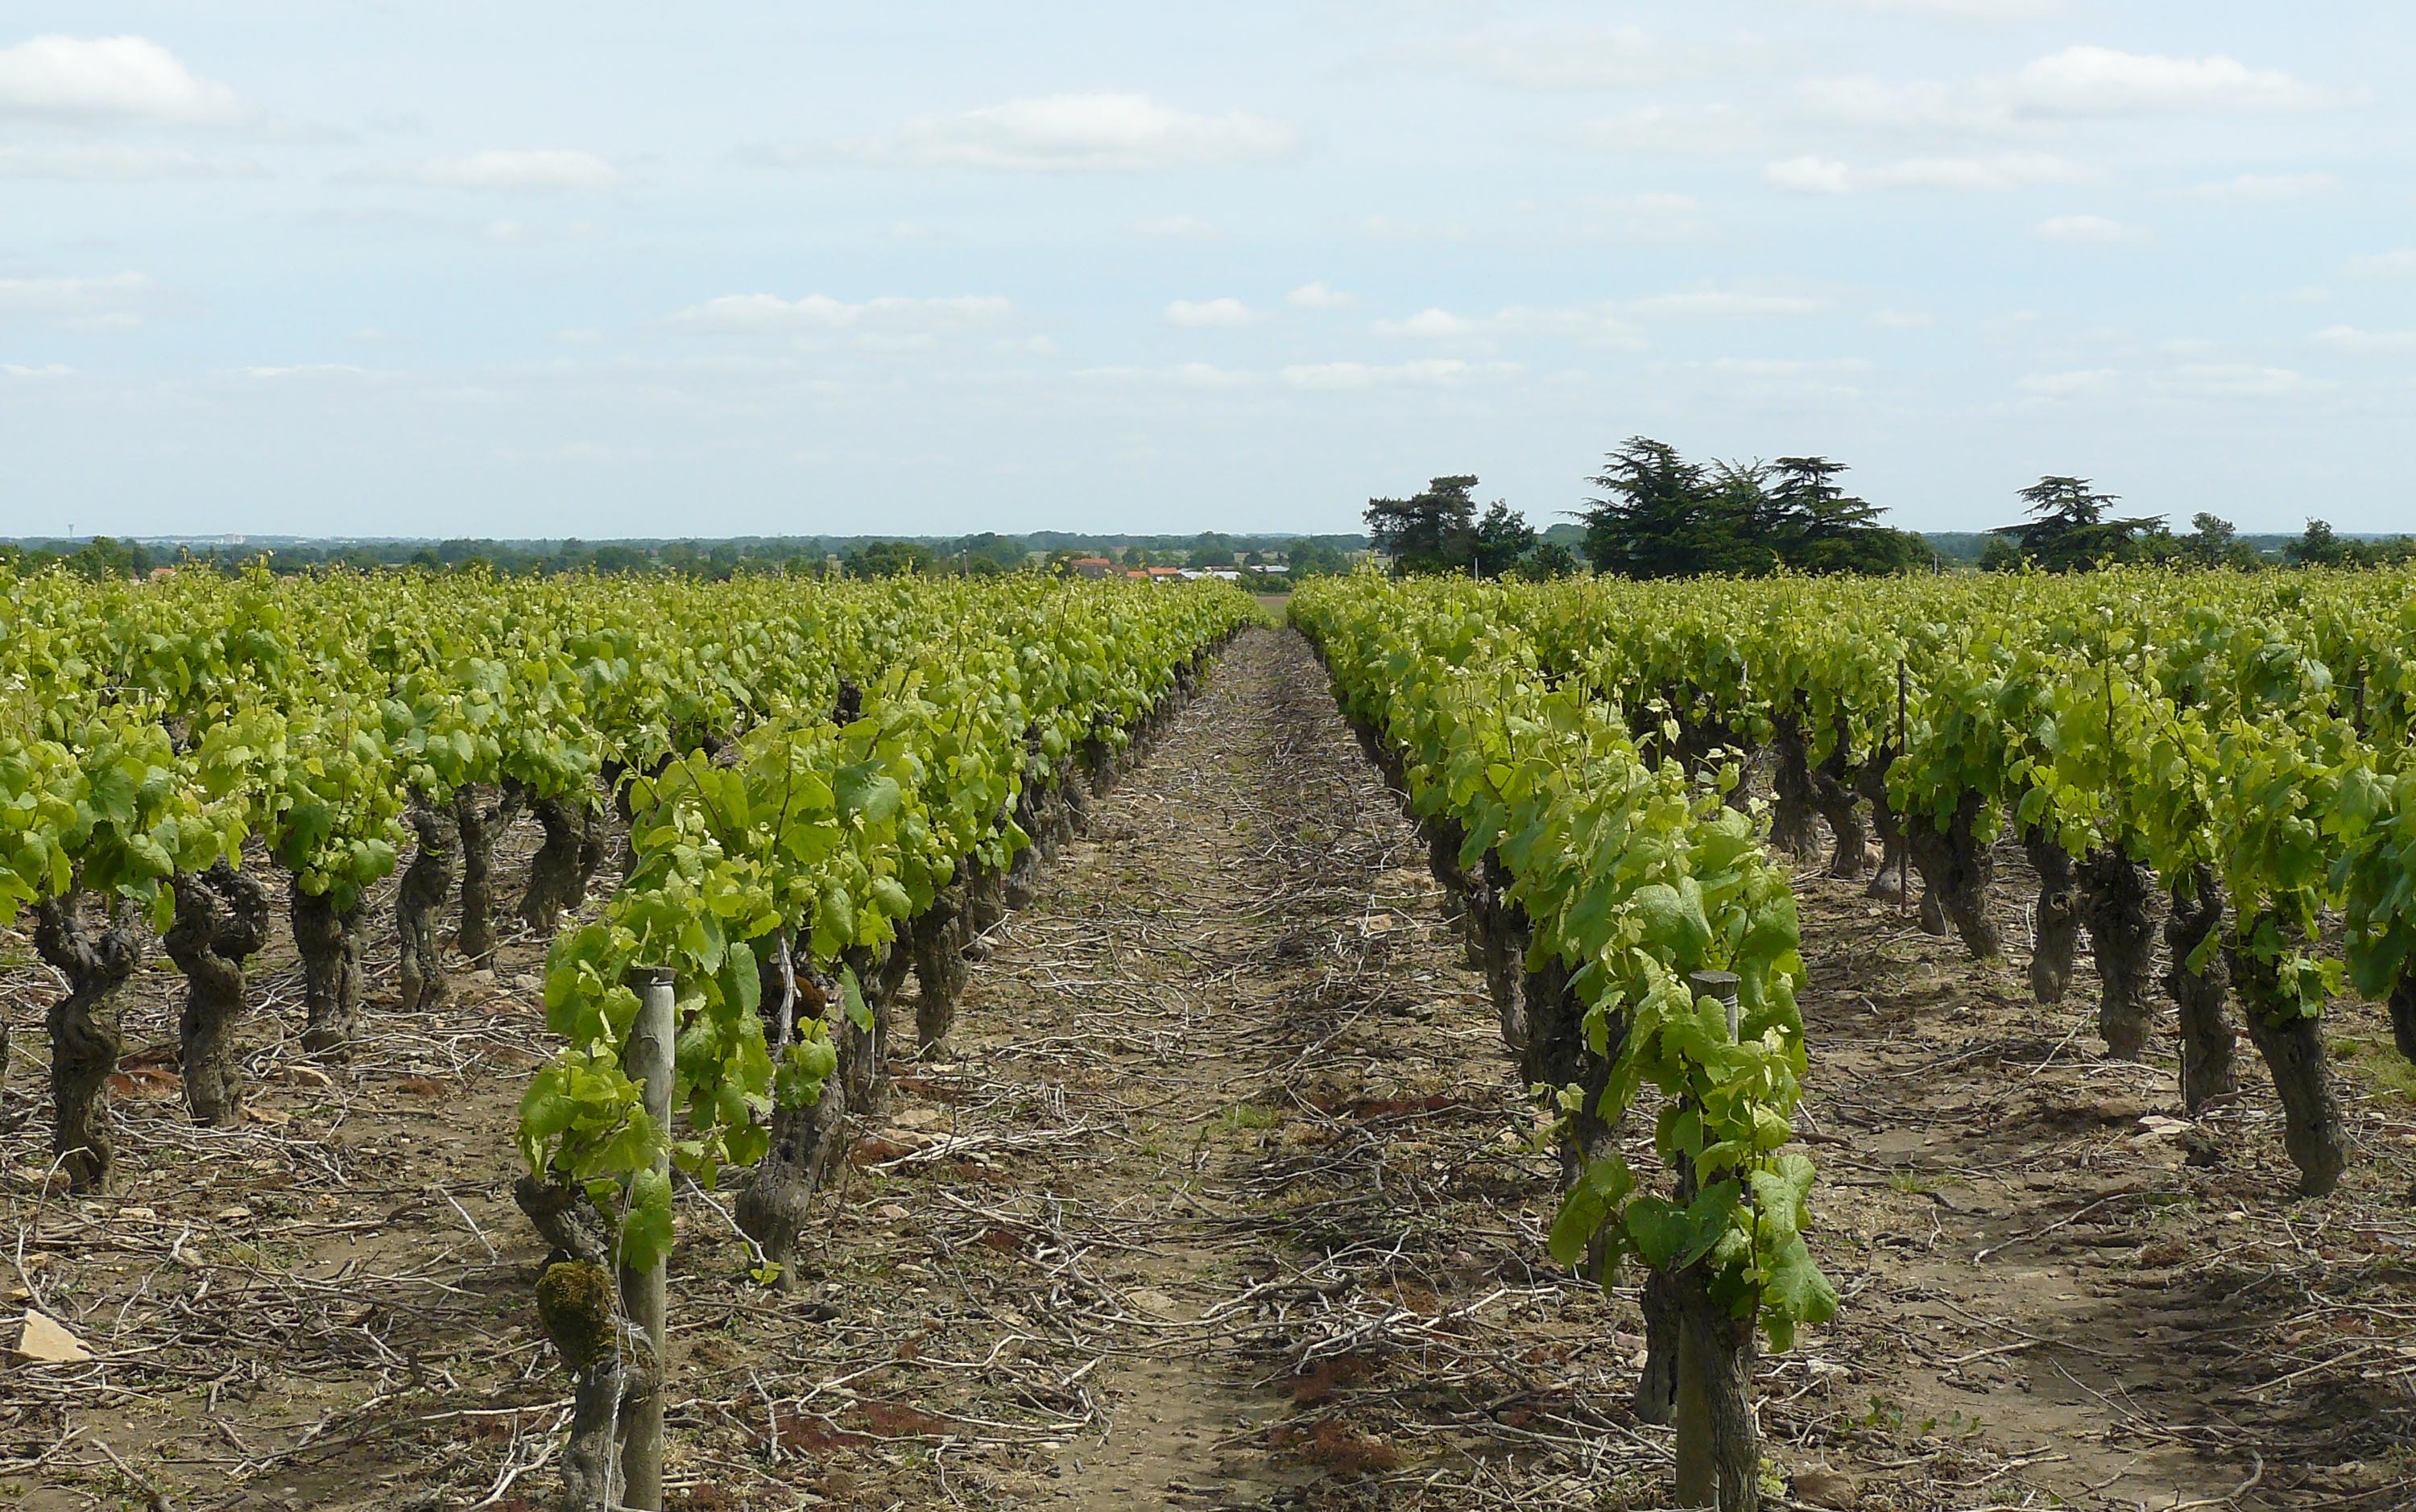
1293, 577, 1836, 1512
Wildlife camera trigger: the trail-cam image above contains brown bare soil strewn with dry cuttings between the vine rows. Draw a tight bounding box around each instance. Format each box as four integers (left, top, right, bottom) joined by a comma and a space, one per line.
0, 630, 2416, 1512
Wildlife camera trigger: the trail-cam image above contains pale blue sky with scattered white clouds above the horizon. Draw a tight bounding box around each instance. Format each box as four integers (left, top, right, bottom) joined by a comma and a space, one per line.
0, 0, 2416, 539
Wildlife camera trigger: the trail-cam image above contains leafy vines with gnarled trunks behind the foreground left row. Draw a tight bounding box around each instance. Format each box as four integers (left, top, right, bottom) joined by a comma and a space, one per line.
0, 572, 1239, 1188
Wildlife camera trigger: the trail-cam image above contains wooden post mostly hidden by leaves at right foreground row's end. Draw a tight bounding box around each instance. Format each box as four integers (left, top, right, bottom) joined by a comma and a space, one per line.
1672, 971, 1761, 1512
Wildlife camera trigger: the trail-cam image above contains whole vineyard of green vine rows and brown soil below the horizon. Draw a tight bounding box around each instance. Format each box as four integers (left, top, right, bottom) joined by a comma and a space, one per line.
0, 570, 2416, 1512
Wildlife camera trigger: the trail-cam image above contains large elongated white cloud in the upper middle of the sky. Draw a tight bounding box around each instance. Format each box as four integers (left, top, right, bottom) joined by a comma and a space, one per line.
831, 94, 1300, 174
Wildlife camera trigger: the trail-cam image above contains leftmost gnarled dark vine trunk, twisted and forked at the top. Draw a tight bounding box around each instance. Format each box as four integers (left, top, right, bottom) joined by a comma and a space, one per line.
34, 891, 143, 1191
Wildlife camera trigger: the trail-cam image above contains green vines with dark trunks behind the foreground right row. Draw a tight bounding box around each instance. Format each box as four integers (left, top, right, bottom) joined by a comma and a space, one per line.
1498, 570, 2416, 1193
